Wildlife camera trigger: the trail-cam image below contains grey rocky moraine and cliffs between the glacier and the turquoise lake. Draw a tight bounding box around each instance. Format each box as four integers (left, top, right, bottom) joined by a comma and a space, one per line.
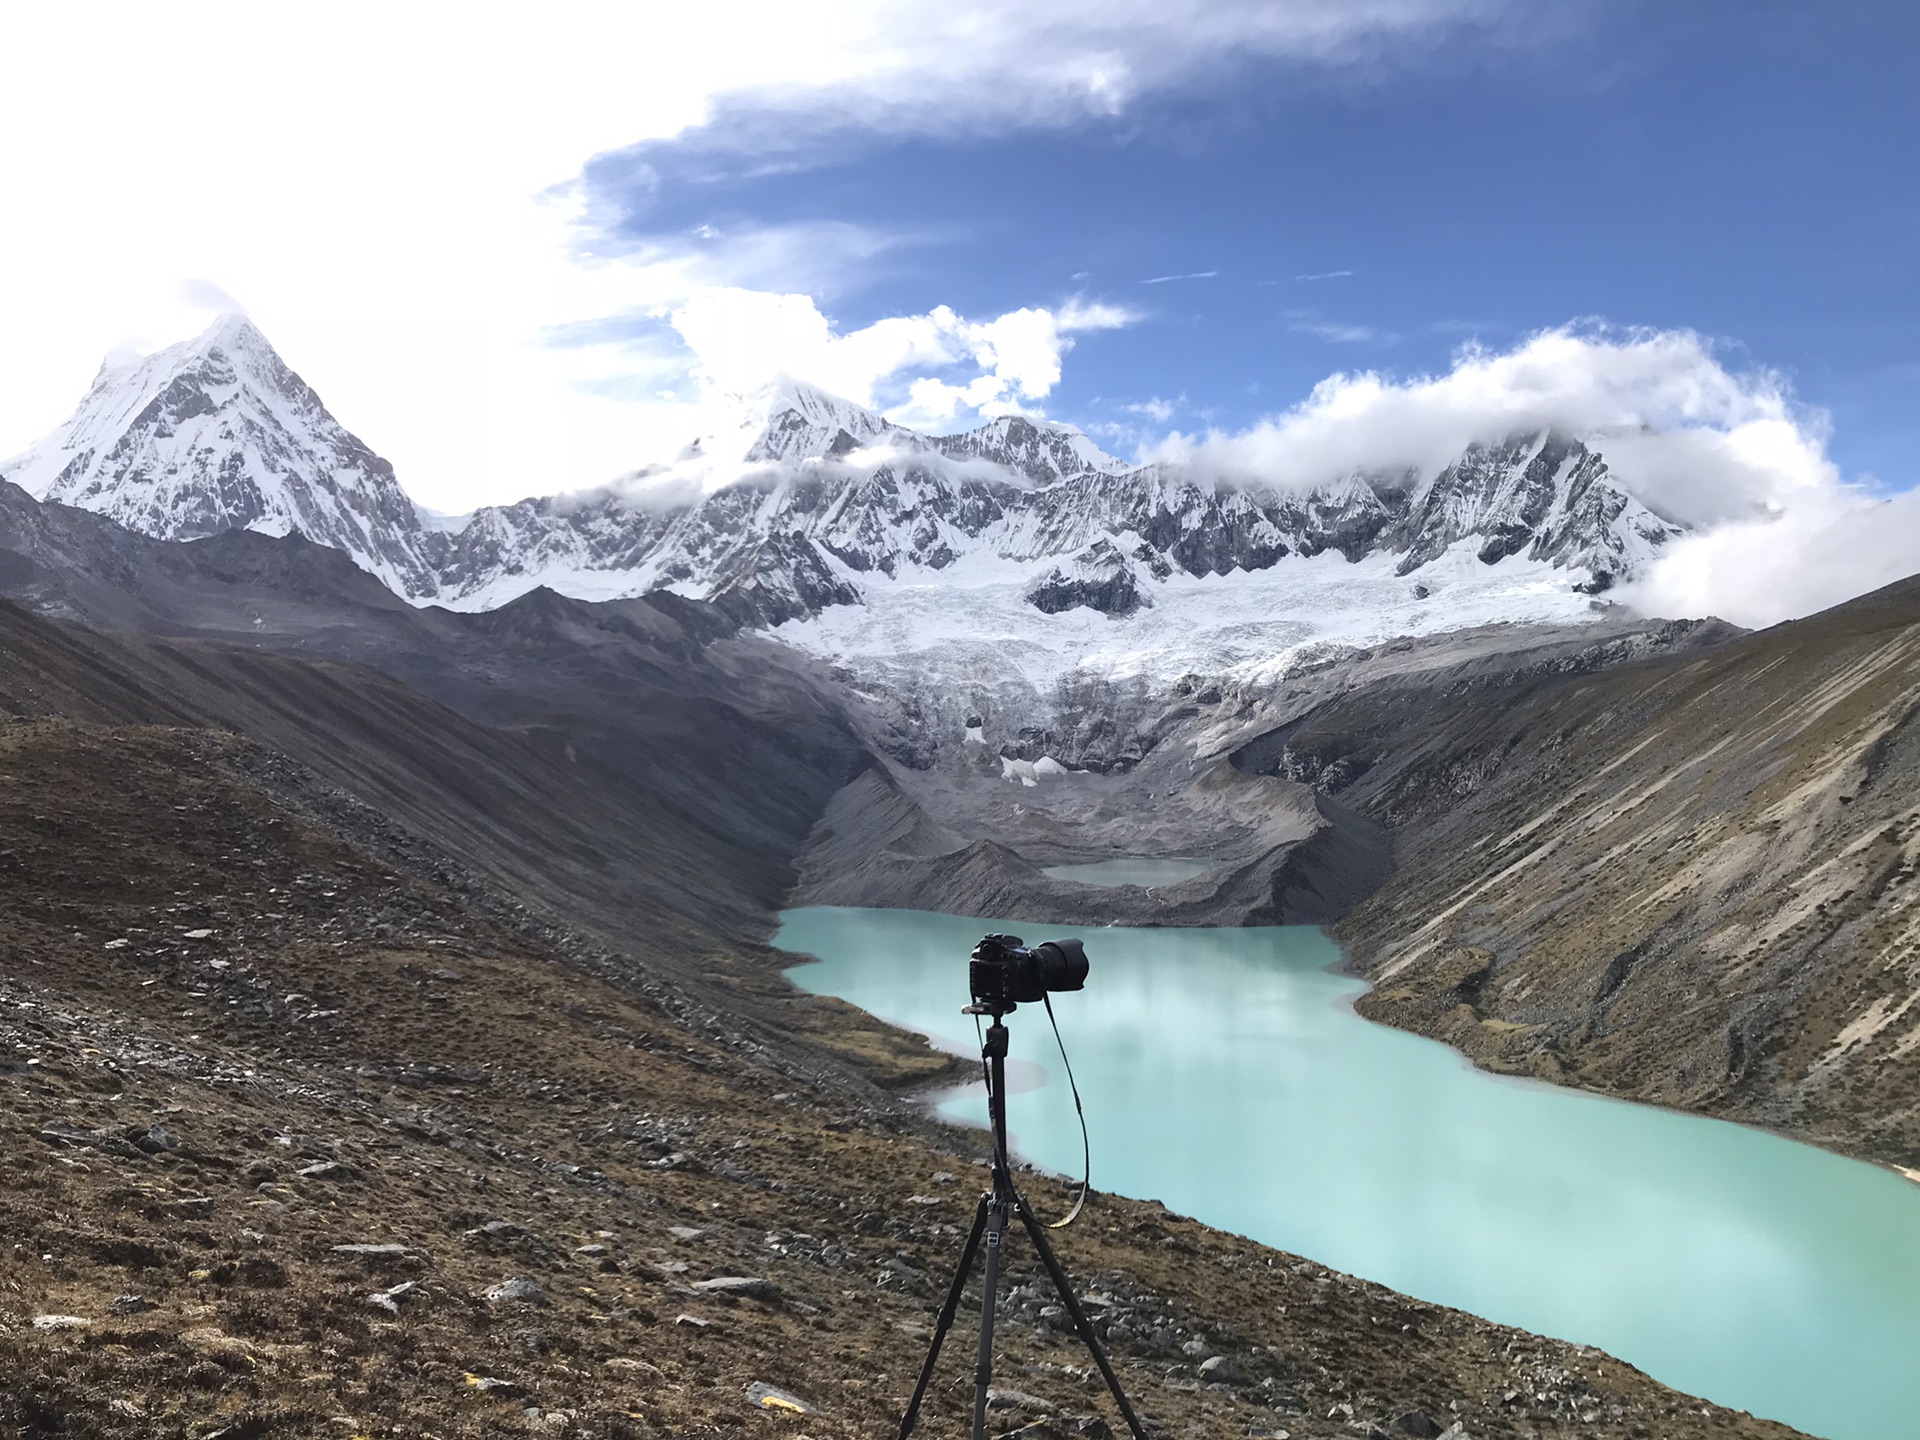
793, 620, 1740, 925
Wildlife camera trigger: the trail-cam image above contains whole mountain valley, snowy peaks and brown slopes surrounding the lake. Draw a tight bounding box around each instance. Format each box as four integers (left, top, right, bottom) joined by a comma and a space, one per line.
0, 319, 1920, 1440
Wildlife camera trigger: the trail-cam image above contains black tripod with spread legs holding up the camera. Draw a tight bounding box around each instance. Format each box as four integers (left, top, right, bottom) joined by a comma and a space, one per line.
900, 1004, 1146, 1440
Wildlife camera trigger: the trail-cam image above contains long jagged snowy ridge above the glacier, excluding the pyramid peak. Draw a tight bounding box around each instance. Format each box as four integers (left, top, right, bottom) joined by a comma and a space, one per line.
442, 411, 1676, 624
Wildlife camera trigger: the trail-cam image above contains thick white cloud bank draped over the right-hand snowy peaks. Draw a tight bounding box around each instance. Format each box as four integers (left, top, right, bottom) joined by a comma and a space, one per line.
1152, 326, 1920, 626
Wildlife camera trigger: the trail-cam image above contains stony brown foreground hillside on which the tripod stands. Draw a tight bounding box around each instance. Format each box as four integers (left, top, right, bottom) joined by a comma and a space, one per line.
0, 720, 1791, 1440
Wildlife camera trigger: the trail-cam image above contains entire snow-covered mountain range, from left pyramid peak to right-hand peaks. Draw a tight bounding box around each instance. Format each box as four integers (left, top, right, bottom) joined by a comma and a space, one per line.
0, 319, 1678, 656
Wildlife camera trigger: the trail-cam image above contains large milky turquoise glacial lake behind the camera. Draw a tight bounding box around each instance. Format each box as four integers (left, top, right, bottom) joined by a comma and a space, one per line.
774, 908, 1920, 1440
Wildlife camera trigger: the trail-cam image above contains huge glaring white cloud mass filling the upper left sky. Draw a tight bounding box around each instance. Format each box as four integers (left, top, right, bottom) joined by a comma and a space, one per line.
0, 0, 1507, 511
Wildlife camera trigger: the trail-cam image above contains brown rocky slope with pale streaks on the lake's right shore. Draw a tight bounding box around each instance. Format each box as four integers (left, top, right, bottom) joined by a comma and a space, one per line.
1238, 580, 1920, 1169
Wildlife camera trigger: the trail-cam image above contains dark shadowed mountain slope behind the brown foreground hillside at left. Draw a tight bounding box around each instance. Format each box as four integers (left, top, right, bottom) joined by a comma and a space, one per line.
0, 583, 860, 971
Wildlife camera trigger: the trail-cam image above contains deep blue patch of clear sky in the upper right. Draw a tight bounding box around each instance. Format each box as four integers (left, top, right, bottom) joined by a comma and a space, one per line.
586, 0, 1920, 488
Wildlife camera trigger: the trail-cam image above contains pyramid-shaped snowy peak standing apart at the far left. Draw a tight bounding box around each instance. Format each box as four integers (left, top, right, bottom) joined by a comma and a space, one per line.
0, 315, 436, 595
